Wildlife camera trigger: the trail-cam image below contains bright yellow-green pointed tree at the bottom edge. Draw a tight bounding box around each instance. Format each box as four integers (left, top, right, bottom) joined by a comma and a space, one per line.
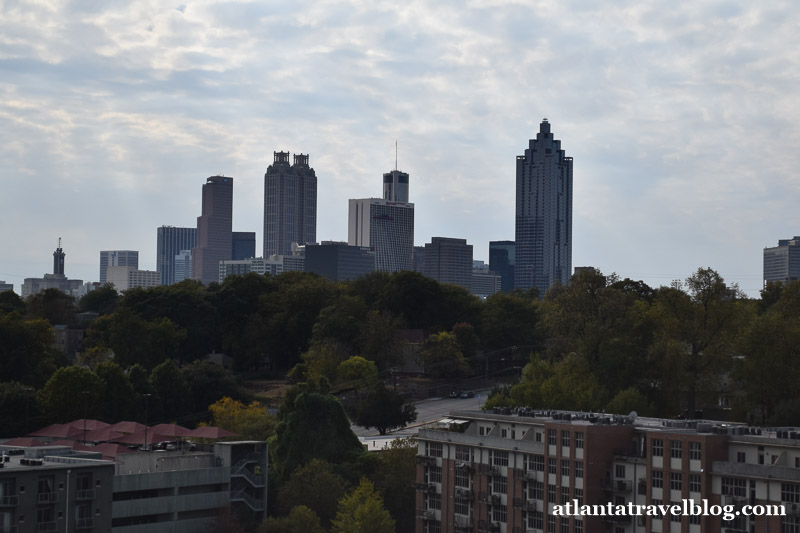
331, 479, 395, 533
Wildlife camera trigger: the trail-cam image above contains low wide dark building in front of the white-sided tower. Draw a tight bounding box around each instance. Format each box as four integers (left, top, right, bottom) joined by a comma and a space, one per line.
305, 241, 375, 281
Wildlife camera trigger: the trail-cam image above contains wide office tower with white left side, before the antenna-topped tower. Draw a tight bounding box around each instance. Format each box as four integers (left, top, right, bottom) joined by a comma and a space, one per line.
347, 198, 414, 272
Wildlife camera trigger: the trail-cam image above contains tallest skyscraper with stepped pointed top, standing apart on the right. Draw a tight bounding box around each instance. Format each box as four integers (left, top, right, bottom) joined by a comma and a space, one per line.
514, 119, 572, 297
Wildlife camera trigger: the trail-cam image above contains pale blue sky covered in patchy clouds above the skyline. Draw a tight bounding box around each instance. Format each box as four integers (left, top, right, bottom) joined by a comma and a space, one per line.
0, 0, 800, 297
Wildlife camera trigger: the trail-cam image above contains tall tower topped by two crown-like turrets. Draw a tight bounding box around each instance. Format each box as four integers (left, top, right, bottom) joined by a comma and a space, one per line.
263, 152, 317, 257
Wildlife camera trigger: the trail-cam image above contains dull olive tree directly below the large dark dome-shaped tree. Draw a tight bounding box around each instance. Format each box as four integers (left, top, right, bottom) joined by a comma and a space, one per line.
278, 459, 347, 527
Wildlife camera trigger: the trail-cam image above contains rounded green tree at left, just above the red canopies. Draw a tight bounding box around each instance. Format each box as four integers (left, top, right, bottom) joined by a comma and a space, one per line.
36, 366, 105, 423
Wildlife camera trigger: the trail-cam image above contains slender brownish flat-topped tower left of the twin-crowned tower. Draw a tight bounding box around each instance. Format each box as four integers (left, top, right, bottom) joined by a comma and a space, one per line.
192, 176, 233, 284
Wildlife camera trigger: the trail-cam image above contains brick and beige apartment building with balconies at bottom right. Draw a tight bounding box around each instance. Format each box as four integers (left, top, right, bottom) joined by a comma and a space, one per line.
416, 409, 800, 533
